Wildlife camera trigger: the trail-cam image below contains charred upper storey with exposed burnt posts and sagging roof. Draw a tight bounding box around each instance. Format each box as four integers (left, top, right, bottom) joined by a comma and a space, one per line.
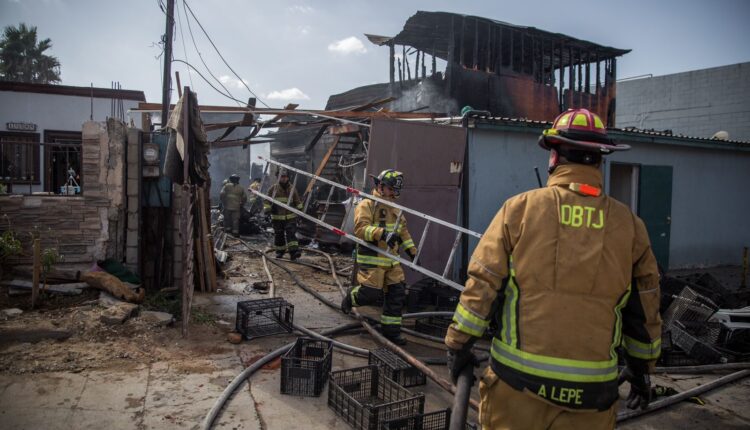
326, 11, 630, 126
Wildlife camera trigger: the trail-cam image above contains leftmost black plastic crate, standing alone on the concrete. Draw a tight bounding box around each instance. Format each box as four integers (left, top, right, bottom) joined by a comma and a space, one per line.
235, 297, 294, 339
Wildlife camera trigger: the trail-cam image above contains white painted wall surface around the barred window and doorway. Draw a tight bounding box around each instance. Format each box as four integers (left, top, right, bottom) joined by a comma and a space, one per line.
0, 91, 141, 193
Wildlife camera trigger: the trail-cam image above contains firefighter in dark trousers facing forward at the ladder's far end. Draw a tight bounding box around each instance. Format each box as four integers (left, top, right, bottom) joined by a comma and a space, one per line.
263, 169, 302, 260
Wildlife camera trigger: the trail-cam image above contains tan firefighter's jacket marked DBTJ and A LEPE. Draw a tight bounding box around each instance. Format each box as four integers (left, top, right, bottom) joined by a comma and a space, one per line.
445, 165, 661, 410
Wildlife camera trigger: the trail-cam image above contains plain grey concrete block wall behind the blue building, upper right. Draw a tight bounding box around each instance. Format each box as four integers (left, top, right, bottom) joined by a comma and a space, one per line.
615, 63, 750, 141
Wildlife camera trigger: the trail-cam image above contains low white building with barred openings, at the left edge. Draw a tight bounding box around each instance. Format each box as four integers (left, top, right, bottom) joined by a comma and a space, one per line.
0, 82, 146, 194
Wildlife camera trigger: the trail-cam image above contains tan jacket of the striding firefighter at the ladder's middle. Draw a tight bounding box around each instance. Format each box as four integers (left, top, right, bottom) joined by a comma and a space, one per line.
354, 190, 417, 288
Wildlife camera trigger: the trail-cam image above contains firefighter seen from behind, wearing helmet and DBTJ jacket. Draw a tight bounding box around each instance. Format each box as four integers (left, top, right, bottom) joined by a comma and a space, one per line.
445, 109, 661, 430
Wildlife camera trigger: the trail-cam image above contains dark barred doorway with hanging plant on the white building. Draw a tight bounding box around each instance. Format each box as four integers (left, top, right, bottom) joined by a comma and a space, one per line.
44, 130, 83, 194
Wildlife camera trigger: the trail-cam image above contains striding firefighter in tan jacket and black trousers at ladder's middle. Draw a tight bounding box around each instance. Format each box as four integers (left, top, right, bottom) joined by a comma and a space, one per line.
341, 169, 417, 345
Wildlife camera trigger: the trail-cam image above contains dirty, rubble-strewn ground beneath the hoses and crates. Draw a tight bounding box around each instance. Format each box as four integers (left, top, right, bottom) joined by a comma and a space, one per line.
0, 236, 750, 429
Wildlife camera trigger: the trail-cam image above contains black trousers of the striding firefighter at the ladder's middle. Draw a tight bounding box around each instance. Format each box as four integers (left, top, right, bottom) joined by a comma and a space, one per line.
351, 282, 406, 338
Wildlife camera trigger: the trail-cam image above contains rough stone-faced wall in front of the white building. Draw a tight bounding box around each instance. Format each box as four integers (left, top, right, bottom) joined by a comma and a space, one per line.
0, 119, 127, 264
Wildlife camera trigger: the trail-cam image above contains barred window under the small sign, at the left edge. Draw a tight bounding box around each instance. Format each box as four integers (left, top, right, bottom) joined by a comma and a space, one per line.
0, 131, 39, 185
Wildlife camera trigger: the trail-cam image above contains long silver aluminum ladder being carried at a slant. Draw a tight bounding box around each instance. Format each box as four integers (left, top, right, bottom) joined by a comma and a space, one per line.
250, 156, 482, 291
